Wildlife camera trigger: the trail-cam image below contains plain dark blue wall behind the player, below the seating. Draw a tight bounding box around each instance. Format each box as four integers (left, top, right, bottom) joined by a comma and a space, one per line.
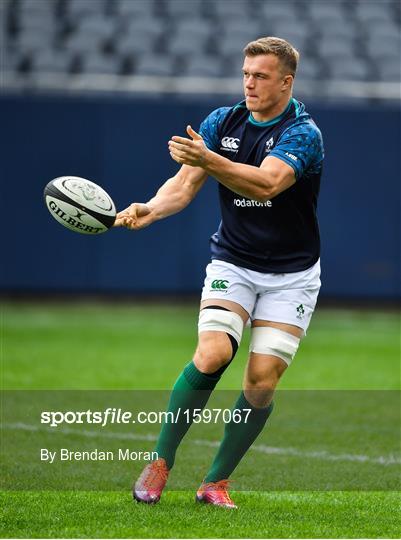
0, 95, 401, 300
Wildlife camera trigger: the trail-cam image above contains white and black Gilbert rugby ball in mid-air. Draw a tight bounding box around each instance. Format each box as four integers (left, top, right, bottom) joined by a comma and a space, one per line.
43, 176, 116, 234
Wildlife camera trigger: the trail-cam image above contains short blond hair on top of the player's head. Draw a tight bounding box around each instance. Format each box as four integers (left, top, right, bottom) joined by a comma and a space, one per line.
244, 37, 299, 77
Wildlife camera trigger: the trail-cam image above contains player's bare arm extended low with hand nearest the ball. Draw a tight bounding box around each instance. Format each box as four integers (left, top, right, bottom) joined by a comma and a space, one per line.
114, 165, 207, 230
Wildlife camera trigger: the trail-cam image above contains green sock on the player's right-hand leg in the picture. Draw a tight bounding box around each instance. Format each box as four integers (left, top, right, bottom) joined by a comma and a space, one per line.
204, 392, 273, 482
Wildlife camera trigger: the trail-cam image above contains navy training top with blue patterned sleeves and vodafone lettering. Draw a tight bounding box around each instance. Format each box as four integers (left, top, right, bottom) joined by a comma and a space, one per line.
200, 98, 324, 273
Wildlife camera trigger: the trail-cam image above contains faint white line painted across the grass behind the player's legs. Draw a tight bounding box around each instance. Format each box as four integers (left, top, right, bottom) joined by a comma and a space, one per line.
1, 422, 401, 466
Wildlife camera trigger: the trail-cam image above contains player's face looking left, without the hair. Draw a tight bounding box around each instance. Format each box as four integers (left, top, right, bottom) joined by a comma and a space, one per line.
242, 54, 291, 113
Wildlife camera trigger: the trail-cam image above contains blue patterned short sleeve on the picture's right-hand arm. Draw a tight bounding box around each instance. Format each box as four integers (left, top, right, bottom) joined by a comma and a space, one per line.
269, 122, 324, 180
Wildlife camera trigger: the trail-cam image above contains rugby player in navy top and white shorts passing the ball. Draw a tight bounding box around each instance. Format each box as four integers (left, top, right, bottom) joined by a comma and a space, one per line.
116, 37, 323, 508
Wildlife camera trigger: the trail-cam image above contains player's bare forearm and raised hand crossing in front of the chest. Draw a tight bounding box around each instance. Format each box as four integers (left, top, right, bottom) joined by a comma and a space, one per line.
169, 126, 296, 202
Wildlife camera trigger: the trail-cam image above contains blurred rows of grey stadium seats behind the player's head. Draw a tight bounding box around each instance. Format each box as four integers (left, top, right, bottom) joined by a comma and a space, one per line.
0, 0, 401, 81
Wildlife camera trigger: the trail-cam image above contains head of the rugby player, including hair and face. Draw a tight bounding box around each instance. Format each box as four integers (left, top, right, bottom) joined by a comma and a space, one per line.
243, 37, 299, 121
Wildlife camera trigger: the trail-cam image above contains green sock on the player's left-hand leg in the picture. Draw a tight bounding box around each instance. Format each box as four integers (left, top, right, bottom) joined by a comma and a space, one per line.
155, 362, 220, 469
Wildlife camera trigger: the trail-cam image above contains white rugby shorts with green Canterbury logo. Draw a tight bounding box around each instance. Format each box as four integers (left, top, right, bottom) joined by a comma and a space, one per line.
202, 260, 321, 333
